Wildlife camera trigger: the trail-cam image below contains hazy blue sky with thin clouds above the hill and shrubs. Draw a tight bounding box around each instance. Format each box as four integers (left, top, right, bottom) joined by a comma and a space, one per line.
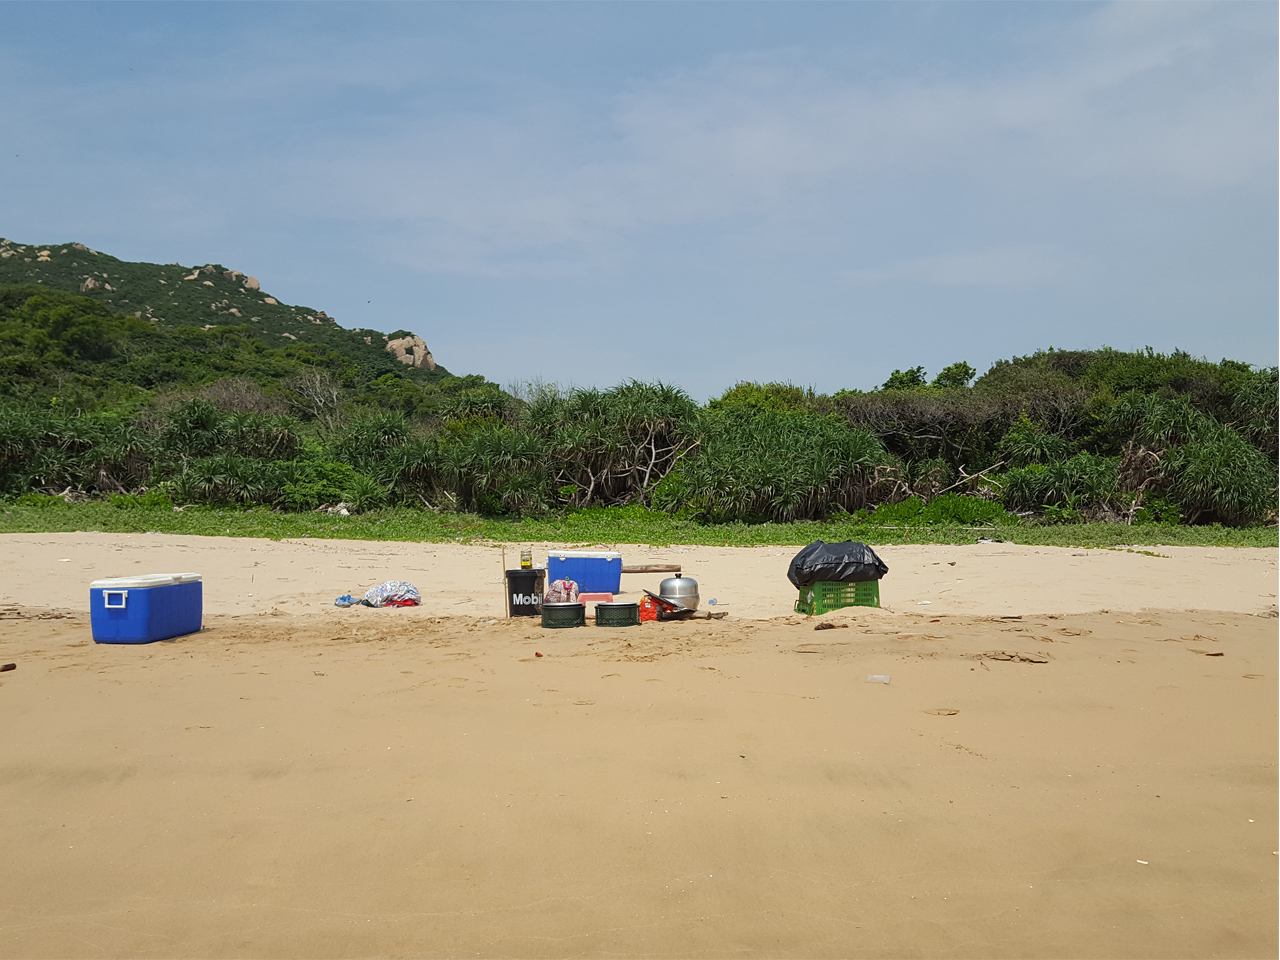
0, 3, 1280, 399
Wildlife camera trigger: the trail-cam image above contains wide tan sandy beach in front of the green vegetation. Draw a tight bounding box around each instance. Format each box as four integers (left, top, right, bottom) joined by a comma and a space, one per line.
0, 534, 1280, 957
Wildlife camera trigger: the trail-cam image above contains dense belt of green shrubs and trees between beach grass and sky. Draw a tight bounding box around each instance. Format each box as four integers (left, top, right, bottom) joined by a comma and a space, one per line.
0, 293, 1277, 526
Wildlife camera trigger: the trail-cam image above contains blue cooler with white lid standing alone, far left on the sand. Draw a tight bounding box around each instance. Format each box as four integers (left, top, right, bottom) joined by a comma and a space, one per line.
88, 573, 205, 644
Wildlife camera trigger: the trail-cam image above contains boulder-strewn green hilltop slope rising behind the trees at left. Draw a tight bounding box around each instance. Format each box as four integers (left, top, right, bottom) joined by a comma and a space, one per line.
0, 239, 449, 384
